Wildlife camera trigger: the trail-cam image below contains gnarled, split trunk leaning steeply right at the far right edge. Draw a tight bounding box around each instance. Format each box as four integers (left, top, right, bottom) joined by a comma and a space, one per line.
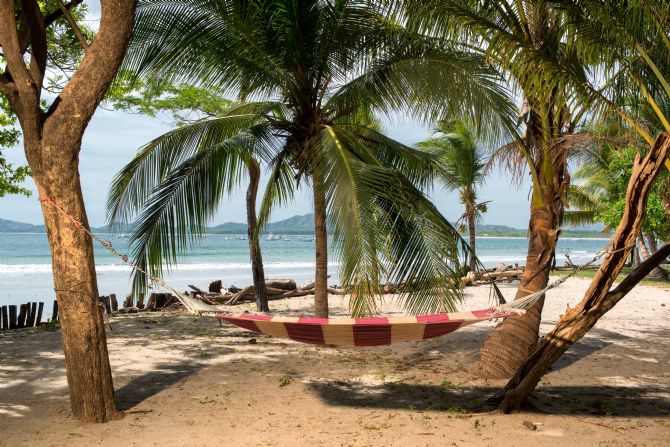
497, 133, 670, 413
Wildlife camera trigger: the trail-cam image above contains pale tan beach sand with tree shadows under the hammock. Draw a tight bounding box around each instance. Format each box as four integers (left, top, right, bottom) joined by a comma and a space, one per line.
0, 279, 670, 447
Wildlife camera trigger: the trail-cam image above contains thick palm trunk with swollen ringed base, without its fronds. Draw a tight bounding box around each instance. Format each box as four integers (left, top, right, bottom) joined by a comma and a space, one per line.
477, 104, 569, 379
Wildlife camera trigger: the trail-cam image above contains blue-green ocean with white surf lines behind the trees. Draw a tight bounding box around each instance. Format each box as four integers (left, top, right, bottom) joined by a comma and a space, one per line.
0, 233, 607, 315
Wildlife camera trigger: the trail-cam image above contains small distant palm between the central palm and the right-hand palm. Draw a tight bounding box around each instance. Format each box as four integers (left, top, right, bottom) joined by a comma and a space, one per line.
419, 121, 487, 271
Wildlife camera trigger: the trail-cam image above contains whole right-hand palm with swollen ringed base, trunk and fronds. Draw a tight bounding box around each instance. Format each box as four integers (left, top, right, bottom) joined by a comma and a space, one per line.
413, 0, 588, 378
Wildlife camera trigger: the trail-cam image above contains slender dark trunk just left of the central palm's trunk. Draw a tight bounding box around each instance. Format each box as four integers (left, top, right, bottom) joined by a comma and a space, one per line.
247, 158, 270, 312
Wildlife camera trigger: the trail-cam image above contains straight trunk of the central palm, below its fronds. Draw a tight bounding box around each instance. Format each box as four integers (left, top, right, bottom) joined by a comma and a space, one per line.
312, 162, 328, 318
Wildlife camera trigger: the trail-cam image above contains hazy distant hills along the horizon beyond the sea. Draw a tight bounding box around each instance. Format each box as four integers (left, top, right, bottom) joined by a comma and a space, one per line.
0, 213, 609, 238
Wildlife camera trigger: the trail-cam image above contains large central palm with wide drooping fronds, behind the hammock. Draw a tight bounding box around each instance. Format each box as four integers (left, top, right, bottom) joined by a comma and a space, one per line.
109, 0, 511, 317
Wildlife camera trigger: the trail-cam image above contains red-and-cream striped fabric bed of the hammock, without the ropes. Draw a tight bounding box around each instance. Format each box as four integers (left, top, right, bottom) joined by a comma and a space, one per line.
220, 309, 523, 346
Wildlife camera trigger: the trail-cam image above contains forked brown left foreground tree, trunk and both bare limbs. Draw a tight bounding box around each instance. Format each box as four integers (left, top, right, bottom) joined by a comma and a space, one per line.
0, 0, 135, 422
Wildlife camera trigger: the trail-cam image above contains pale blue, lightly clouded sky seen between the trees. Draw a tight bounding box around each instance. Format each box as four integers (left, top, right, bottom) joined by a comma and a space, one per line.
0, 2, 530, 228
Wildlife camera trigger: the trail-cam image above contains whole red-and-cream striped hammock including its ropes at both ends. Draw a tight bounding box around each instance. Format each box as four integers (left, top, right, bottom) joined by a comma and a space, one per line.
38, 194, 607, 346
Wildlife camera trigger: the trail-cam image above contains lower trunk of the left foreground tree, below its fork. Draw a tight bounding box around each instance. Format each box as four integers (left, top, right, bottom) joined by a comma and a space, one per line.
32, 148, 122, 422
